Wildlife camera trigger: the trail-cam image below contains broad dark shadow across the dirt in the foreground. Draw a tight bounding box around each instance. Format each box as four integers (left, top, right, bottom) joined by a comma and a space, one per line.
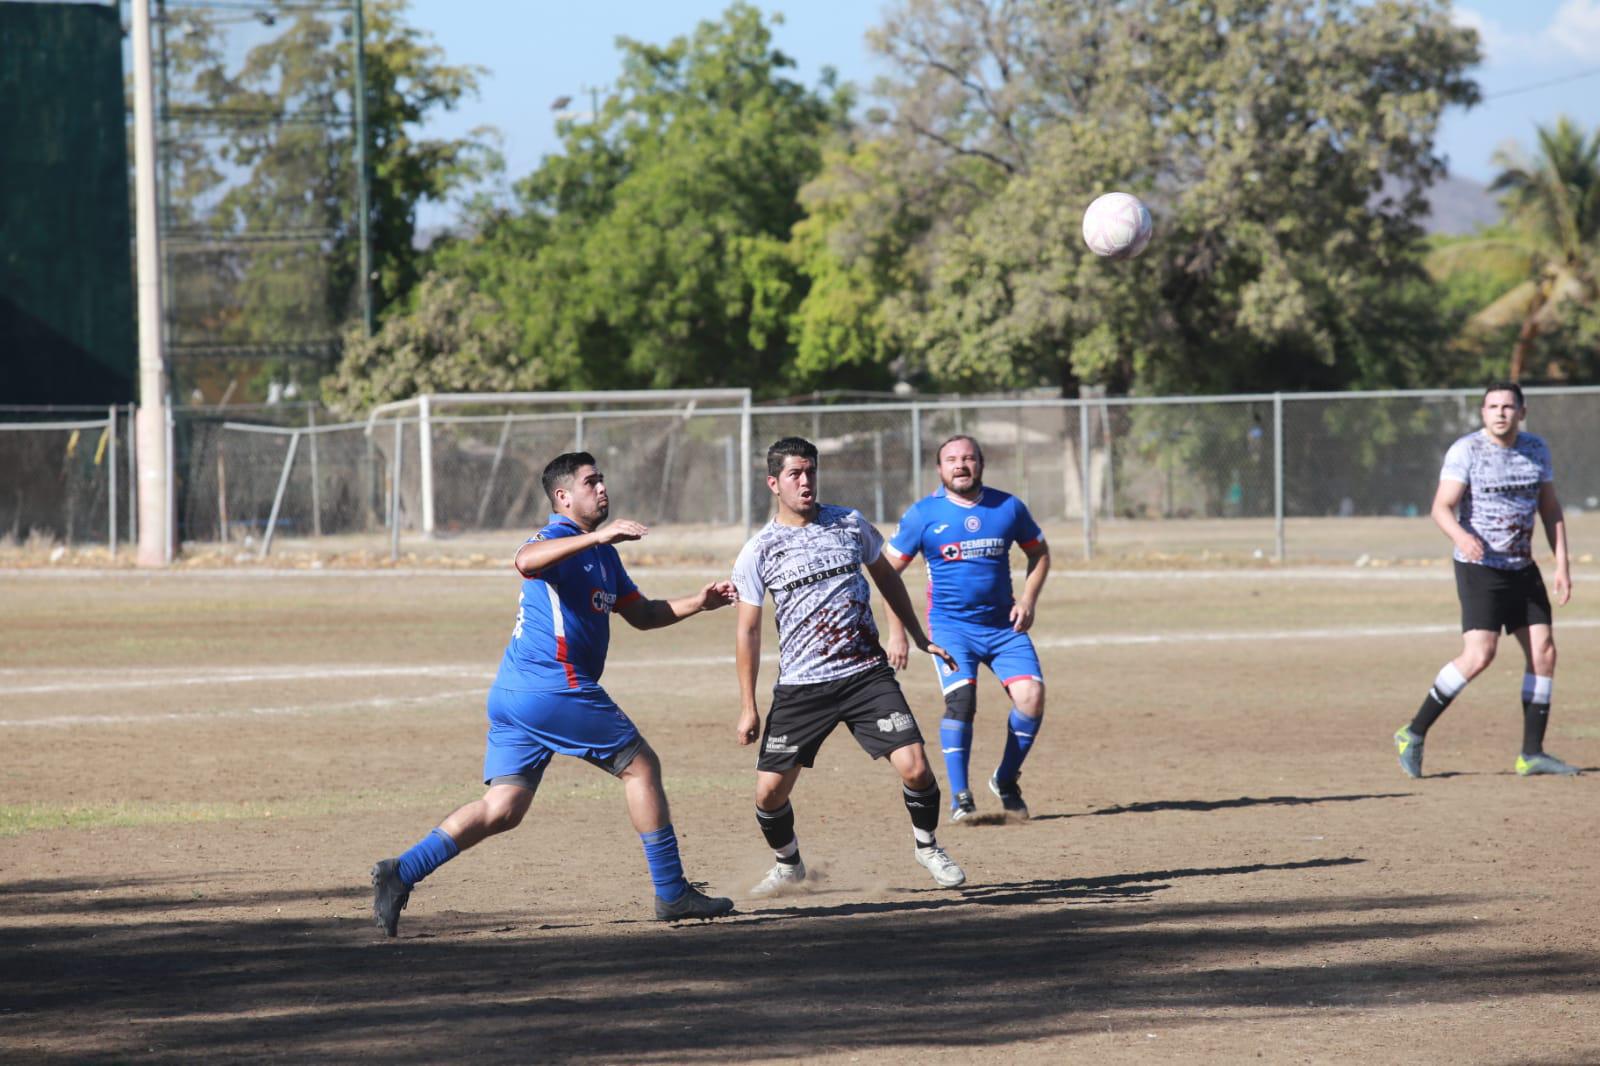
0, 856, 1600, 1063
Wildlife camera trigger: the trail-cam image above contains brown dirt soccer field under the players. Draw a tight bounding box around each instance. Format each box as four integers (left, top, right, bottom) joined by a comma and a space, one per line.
0, 531, 1600, 1063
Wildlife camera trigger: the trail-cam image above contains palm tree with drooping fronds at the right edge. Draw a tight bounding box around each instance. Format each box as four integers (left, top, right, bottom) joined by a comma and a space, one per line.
1474, 115, 1600, 381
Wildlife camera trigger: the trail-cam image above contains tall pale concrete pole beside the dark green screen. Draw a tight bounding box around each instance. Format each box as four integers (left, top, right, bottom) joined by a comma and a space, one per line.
131, 0, 173, 567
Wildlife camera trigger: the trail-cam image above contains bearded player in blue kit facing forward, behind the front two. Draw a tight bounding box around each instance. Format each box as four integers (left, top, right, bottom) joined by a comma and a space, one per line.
883, 435, 1050, 821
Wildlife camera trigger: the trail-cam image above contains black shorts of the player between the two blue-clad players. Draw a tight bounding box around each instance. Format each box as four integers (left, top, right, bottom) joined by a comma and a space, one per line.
755, 664, 922, 773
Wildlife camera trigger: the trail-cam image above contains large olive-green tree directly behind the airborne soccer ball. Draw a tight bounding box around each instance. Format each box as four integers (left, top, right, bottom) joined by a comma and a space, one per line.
802, 0, 1477, 392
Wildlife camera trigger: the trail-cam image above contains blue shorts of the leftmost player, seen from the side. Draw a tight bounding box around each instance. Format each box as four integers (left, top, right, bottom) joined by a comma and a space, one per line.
483, 685, 645, 787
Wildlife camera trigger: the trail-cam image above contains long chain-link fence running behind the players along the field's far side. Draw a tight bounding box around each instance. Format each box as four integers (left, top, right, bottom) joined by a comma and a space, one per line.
0, 387, 1600, 560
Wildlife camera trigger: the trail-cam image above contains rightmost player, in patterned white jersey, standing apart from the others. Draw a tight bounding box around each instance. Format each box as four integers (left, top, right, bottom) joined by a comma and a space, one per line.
1395, 381, 1578, 778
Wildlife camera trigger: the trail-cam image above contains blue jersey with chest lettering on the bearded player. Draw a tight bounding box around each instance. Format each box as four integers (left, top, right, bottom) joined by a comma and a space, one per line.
885, 485, 1043, 626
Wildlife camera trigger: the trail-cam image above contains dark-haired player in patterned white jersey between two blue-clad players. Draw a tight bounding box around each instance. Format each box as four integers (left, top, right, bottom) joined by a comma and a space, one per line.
733, 437, 966, 896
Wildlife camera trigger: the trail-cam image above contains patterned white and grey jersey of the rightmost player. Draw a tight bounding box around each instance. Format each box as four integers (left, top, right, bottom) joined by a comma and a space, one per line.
1438, 431, 1555, 570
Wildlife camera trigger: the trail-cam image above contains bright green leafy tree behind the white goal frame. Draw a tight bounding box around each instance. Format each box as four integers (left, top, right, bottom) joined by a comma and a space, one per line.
339, 3, 850, 403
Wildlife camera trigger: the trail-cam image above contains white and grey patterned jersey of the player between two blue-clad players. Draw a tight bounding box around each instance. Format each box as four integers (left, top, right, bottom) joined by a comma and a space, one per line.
733, 504, 885, 685
